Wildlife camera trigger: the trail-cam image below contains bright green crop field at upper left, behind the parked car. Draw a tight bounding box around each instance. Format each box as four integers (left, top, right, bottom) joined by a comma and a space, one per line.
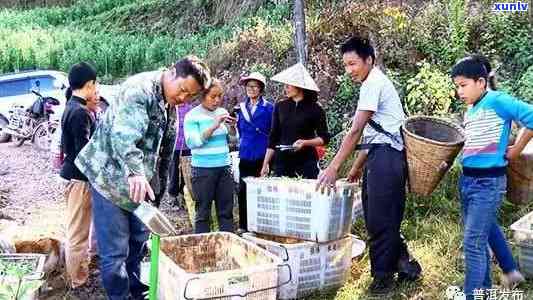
0, 0, 288, 78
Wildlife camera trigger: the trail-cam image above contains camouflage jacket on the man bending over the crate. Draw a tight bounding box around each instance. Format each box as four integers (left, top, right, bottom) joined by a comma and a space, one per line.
76, 71, 176, 211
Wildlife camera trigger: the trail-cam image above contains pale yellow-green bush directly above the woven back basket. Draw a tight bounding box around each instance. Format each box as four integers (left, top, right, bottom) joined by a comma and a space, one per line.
406, 62, 457, 116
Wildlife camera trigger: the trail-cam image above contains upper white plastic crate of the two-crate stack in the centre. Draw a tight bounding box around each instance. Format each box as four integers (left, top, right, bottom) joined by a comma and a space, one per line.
244, 177, 360, 242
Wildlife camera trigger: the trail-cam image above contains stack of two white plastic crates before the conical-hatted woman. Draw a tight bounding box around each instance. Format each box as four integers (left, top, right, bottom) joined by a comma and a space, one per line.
243, 177, 365, 299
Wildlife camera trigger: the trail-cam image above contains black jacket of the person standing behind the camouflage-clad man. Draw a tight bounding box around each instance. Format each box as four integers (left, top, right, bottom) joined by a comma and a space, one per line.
60, 96, 96, 181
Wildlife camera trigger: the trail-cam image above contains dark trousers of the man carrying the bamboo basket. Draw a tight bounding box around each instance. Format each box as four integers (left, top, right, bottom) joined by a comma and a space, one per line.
362, 145, 409, 277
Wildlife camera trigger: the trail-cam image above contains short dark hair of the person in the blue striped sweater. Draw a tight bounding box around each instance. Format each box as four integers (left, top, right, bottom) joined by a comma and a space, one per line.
451, 55, 496, 90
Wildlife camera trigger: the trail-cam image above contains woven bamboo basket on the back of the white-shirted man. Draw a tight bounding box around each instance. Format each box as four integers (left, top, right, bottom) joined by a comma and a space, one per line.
402, 116, 465, 196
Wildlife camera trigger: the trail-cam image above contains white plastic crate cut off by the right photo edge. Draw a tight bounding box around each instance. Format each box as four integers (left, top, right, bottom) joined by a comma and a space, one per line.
511, 212, 533, 278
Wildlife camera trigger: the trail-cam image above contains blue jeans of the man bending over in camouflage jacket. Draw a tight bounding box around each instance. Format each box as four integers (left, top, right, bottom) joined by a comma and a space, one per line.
91, 188, 150, 300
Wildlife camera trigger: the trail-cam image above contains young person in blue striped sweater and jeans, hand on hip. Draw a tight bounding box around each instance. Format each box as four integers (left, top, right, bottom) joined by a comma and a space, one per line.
451, 56, 533, 299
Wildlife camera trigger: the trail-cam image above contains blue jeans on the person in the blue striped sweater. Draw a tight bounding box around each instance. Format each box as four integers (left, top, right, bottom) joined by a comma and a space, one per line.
459, 175, 516, 299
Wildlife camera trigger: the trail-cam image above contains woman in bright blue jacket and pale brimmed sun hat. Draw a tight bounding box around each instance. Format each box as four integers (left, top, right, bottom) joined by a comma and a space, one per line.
235, 72, 274, 231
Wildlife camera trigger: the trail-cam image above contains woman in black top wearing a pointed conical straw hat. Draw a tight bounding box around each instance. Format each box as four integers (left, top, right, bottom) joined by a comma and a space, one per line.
261, 63, 330, 179
